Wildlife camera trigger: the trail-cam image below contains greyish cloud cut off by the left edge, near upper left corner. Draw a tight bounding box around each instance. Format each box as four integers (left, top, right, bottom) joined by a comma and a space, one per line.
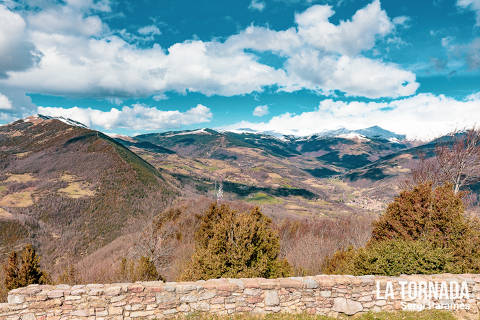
0, 4, 39, 78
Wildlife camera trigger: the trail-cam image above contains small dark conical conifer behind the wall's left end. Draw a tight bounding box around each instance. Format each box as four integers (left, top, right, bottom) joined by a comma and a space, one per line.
18, 244, 49, 287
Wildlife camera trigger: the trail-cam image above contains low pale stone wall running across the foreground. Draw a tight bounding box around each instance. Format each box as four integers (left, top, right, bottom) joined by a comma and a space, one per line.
0, 274, 480, 320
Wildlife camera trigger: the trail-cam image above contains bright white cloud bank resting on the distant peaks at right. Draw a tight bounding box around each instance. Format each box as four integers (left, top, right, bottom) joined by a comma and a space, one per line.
227, 93, 480, 140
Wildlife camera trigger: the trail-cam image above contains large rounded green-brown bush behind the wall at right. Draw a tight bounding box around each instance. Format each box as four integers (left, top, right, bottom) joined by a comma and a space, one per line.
322, 184, 480, 275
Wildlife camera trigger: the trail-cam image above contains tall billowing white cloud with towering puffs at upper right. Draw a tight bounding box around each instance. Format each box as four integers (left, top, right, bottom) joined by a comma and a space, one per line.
225, 1, 419, 98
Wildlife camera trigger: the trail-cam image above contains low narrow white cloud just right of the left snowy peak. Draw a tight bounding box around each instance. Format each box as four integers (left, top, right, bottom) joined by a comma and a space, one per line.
38, 104, 212, 130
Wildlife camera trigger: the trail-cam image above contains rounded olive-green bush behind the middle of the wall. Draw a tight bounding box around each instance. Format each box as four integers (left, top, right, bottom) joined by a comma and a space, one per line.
181, 204, 291, 280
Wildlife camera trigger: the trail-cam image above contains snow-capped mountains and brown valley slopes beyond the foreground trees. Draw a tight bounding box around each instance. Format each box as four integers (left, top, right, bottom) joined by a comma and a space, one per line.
0, 115, 464, 278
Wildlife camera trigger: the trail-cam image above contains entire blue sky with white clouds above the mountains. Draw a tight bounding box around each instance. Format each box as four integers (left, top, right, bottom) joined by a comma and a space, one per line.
0, 0, 480, 140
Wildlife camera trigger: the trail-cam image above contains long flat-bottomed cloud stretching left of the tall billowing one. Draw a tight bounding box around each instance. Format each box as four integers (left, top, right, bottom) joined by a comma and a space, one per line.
4, 35, 285, 96
